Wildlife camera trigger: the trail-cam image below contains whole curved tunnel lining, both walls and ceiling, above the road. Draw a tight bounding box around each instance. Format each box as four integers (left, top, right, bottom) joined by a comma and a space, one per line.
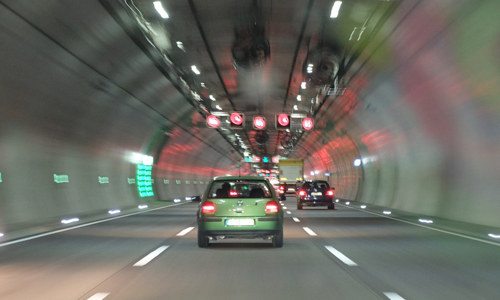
0, 0, 500, 299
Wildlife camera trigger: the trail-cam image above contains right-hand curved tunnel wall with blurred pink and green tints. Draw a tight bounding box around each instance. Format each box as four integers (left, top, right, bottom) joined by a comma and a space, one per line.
346, 1, 500, 227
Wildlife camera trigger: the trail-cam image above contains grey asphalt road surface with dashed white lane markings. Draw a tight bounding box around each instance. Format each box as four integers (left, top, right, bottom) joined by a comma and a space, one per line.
0, 197, 500, 300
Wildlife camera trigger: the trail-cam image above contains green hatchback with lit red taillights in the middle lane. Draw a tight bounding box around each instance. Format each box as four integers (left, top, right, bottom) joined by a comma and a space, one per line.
197, 176, 283, 248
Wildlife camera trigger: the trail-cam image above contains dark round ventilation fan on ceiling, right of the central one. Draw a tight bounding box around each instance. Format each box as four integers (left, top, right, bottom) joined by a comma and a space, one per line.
303, 48, 339, 87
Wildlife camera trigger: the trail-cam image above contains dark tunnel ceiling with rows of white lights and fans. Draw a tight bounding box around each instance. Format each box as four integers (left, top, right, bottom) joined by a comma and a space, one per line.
100, 0, 396, 169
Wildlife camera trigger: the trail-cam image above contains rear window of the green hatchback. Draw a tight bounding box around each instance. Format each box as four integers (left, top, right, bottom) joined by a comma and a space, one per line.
208, 180, 272, 198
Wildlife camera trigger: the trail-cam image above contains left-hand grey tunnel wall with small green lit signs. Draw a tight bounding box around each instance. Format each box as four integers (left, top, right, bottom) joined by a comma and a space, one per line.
0, 2, 226, 235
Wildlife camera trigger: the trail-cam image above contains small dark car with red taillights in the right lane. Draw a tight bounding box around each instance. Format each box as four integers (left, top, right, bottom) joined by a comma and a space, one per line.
297, 180, 335, 209
